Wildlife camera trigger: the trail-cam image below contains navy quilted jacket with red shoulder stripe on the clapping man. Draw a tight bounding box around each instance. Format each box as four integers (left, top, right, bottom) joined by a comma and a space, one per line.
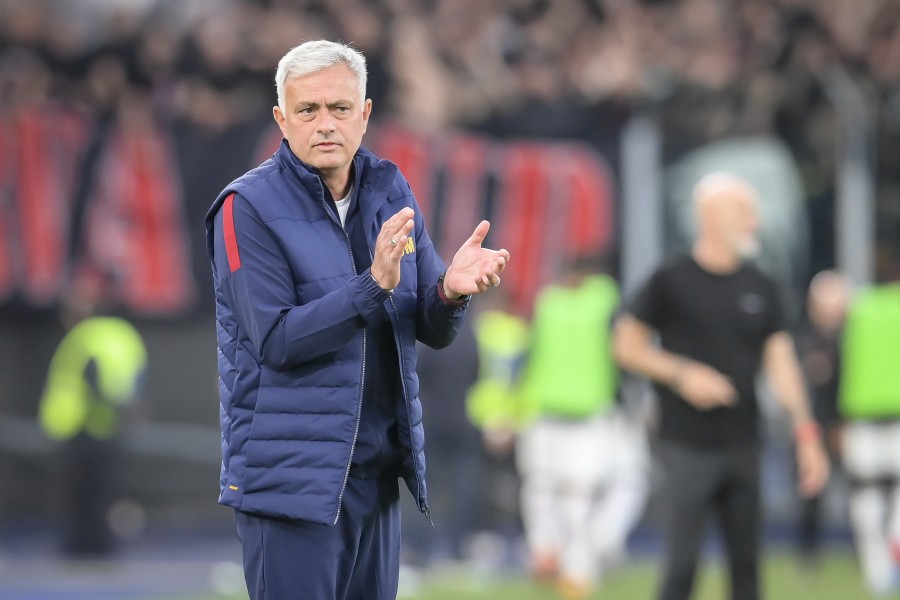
206, 141, 465, 525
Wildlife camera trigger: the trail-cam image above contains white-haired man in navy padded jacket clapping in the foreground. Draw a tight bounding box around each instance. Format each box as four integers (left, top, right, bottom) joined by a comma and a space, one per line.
206, 41, 509, 599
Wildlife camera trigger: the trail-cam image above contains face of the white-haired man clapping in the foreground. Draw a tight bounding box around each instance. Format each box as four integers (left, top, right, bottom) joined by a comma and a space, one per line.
273, 64, 372, 175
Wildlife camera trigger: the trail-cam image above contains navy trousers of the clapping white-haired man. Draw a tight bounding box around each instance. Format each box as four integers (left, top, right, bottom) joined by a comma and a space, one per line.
234, 476, 400, 600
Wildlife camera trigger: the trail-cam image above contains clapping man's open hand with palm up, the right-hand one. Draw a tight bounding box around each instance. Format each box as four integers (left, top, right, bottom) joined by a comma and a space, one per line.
444, 221, 509, 300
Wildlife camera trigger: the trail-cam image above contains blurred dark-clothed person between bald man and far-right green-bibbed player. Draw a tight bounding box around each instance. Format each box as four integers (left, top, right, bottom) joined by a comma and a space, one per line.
794, 270, 851, 566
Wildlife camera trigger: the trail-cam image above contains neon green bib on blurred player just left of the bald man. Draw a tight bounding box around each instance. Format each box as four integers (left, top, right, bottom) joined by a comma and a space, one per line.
522, 275, 619, 419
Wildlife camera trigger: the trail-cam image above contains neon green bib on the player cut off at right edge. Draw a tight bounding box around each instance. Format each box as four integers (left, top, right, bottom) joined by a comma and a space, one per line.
838, 284, 900, 420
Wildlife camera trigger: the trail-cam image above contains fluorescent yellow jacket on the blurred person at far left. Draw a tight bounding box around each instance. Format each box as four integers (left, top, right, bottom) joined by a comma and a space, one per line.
39, 317, 147, 440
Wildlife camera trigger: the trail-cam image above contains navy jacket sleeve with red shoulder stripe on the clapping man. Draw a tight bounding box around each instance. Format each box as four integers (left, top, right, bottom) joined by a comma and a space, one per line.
213, 195, 388, 370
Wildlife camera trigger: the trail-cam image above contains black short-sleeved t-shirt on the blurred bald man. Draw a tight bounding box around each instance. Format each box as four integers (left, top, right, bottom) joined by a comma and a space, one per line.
628, 256, 786, 446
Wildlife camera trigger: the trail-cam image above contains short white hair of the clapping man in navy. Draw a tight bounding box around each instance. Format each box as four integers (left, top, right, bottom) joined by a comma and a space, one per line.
275, 40, 366, 112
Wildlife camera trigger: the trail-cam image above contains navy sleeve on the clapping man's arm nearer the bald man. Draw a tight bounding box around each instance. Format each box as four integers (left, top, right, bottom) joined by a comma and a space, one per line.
414, 195, 469, 348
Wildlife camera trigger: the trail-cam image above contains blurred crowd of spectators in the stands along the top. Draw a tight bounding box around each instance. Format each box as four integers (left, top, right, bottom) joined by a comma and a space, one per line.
0, 0, 900, 282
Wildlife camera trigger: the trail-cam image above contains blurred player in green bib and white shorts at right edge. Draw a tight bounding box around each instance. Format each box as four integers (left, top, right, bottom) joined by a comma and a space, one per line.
838, 282, 900, 595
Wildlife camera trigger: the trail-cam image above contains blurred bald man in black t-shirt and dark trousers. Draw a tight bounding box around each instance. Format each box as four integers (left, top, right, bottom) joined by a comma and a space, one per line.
614, 173, 828, 600
